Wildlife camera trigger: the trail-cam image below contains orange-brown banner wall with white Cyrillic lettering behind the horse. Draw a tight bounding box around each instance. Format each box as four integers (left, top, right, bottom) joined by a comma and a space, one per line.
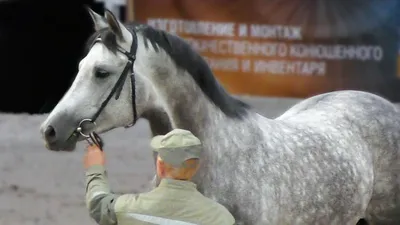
127, 0, 400, 101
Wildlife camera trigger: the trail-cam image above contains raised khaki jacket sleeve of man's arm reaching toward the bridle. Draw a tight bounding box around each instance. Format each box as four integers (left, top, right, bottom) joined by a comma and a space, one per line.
86, 165, 119, 225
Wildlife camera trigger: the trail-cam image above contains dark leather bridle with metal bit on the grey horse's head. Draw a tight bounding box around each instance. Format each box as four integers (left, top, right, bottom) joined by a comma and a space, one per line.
71, 31, 137, 150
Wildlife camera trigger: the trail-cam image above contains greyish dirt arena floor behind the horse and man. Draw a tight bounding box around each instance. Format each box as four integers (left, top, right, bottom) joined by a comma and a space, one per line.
0, 96, 396, 225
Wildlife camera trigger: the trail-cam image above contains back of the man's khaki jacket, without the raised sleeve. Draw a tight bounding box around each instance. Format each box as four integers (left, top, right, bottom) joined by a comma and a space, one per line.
115, 179, 235, 225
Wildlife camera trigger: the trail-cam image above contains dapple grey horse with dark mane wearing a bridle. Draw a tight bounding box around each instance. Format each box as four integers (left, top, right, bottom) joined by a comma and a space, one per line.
40, 8, 400, 225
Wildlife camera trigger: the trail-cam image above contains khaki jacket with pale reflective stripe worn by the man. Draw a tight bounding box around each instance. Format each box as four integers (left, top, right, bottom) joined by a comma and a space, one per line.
86, 165, 235, 225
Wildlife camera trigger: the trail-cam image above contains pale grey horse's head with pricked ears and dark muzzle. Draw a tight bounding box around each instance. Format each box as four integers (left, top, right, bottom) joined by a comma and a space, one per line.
40, 9, 159, 151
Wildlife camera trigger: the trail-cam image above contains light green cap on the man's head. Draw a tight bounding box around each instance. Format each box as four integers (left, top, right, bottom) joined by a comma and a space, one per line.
150, 129, 202, 167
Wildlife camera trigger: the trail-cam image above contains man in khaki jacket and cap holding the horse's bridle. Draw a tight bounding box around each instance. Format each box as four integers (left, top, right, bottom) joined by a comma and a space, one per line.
84, 129, 235, 225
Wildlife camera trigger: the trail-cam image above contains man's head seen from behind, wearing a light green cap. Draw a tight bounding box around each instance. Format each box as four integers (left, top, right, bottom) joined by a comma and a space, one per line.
150, 129, 202, 180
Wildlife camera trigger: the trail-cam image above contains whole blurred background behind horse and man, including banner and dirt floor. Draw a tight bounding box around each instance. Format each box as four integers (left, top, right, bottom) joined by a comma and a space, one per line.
0, 0, 400, 225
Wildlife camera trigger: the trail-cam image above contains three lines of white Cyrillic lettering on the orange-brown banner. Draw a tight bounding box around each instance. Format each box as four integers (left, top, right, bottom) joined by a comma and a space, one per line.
147, 18, 384, 76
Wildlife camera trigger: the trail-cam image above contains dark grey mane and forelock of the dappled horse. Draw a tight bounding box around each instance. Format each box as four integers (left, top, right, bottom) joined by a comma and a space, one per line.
85, 22, 250, 118
